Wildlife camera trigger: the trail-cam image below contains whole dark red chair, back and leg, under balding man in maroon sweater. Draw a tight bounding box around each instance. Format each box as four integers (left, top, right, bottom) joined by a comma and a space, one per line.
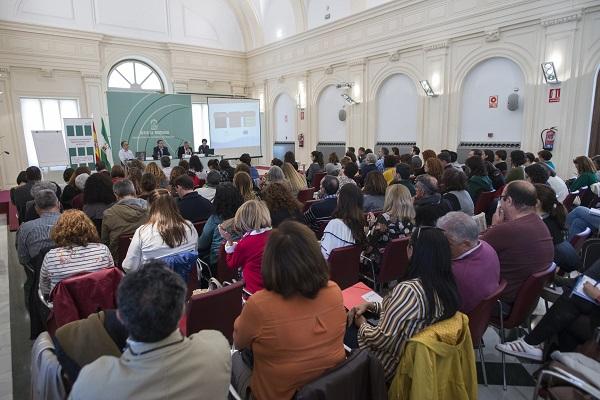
491, 263, 556, 390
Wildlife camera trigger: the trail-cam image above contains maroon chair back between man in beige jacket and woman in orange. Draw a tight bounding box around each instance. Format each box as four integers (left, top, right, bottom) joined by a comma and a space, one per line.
185, 281, 244, 343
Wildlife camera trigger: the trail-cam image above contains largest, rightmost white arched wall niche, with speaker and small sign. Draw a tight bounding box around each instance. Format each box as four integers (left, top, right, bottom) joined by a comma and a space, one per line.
460, 57, 526, 142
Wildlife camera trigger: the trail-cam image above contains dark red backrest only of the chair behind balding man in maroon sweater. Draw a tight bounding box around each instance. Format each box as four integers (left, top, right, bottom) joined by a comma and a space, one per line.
504, 263, 556, 329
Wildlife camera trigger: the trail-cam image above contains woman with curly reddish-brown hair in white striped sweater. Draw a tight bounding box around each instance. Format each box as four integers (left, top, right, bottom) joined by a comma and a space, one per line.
40, 209, 115, 296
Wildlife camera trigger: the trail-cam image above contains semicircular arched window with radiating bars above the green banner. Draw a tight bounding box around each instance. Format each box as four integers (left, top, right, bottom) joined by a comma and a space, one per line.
108, 60, 165, 92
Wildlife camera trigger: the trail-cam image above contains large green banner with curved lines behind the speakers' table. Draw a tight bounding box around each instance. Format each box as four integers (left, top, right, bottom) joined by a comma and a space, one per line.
106, 92, 194, 163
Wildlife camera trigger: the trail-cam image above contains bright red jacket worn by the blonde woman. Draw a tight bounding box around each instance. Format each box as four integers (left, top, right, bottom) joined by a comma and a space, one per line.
227, 230, 271, 293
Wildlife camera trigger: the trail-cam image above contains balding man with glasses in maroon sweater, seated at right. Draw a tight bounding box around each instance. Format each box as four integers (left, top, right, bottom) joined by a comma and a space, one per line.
481, 180, 554, 315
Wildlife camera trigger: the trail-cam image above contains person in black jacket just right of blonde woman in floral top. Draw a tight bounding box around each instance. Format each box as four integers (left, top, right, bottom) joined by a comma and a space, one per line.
413, 174, 449, 226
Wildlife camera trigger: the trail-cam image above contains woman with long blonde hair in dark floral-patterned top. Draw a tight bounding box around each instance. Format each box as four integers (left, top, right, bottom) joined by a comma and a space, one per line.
361, 185, 415, 272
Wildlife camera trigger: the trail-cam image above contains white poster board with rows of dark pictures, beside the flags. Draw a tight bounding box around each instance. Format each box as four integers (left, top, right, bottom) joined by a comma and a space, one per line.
64, 118, 96, 168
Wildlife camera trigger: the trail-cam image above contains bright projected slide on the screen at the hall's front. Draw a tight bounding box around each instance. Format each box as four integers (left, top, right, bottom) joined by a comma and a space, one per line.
208, 97, 262, 158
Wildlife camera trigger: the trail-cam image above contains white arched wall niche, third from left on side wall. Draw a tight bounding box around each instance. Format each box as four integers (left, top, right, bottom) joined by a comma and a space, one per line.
376, 74, 419, 142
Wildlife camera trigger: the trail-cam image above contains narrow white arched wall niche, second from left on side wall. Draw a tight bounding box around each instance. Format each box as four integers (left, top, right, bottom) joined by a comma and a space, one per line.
317, 85, 347, 142
